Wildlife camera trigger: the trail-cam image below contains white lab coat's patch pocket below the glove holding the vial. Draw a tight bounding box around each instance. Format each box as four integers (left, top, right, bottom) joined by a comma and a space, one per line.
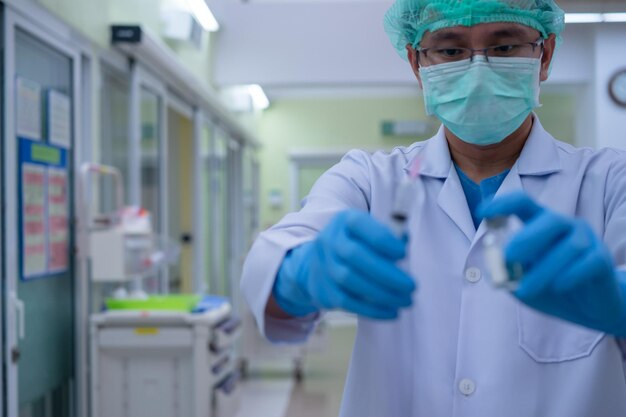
517, 304, 604, 363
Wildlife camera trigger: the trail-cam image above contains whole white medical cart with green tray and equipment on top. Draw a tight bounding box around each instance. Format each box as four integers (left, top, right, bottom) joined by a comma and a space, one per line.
81, 164, 241, 417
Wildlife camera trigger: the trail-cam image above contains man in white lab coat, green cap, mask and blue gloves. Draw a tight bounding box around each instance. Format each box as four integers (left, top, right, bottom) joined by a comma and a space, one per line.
242, 0, 626, 417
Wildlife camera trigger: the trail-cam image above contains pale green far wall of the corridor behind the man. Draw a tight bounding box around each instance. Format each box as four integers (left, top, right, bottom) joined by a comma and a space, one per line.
257, 93, 576, 229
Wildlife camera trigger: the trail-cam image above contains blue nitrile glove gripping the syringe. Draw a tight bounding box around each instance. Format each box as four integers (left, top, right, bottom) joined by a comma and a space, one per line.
273, 211, 415, 320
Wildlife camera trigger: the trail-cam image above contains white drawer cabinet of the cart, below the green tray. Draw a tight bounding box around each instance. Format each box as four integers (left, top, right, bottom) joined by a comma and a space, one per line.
91, 302, 240, 417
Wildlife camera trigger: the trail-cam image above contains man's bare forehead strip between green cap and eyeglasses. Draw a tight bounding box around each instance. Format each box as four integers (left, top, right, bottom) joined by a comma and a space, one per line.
422, 23, 540, 41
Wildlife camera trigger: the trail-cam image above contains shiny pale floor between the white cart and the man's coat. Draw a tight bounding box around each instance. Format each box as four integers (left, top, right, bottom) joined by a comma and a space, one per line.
237, 326, 356, 417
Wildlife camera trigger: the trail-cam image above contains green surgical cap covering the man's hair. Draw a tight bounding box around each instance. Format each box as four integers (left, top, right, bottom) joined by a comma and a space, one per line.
385, 0, 565, 59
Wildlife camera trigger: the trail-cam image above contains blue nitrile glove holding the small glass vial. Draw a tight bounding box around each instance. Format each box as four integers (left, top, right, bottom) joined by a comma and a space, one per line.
481, 192, 626, 337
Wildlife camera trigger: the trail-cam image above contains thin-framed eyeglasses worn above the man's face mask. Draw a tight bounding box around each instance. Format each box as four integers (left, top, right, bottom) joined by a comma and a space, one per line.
417, 39, 543, 65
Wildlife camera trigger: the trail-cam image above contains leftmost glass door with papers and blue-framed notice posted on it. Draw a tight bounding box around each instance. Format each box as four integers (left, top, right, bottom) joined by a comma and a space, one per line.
3, 8, 80, 417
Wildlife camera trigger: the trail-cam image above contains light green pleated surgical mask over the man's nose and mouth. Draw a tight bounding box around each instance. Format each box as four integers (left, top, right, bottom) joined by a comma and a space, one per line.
420, 55, 541, 146
